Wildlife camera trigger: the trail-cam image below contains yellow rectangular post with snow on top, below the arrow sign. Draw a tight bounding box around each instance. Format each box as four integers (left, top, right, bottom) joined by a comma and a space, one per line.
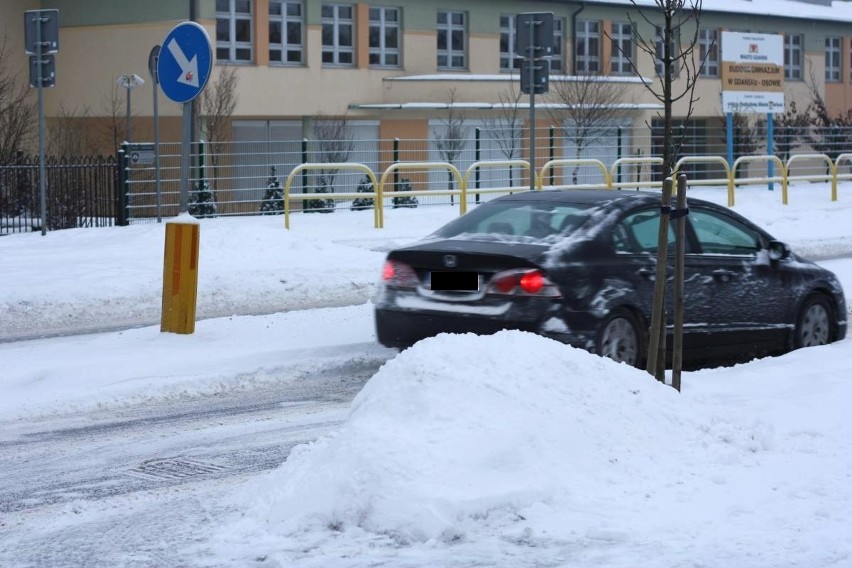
160, 217, 201, 333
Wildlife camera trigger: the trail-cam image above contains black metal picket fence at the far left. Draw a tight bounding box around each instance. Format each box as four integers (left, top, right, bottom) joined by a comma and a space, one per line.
0, 153, 120, 235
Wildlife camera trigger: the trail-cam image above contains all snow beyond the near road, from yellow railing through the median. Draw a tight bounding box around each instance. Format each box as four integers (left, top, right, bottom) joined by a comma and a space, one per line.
0, 185, 852, 420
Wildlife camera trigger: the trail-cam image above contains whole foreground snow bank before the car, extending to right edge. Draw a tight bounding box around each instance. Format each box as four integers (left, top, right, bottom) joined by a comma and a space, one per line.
204, 332, 852, 568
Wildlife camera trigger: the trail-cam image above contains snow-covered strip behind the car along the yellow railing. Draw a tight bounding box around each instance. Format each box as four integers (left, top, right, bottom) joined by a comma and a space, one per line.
0, 183, 852, 341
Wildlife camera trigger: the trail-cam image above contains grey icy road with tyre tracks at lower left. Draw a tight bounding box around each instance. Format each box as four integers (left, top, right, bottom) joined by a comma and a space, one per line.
0, 360, 384, 568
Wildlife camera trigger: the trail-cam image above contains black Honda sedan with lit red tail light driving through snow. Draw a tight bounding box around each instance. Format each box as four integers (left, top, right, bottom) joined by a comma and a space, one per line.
374, 190, 847, 366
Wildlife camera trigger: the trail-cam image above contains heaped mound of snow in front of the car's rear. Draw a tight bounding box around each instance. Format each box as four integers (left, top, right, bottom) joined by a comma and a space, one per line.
240, 331, 784, 556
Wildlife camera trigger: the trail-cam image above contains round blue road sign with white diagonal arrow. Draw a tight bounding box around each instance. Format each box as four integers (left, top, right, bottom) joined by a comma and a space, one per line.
157, 22, 213, 103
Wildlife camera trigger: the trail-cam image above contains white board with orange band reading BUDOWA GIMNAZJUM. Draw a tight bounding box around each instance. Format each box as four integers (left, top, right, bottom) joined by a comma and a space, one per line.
722, 32, 784, 113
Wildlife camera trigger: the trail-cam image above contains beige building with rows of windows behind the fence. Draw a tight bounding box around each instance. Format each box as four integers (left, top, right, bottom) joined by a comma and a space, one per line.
5, 0, 852, 180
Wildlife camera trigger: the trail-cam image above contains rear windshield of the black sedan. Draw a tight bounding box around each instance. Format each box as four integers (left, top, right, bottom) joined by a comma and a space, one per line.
431, 201, 592, 242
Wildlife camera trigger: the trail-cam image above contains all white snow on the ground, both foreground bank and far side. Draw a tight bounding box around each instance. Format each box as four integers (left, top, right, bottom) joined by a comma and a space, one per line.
0, 184, 852, 568
